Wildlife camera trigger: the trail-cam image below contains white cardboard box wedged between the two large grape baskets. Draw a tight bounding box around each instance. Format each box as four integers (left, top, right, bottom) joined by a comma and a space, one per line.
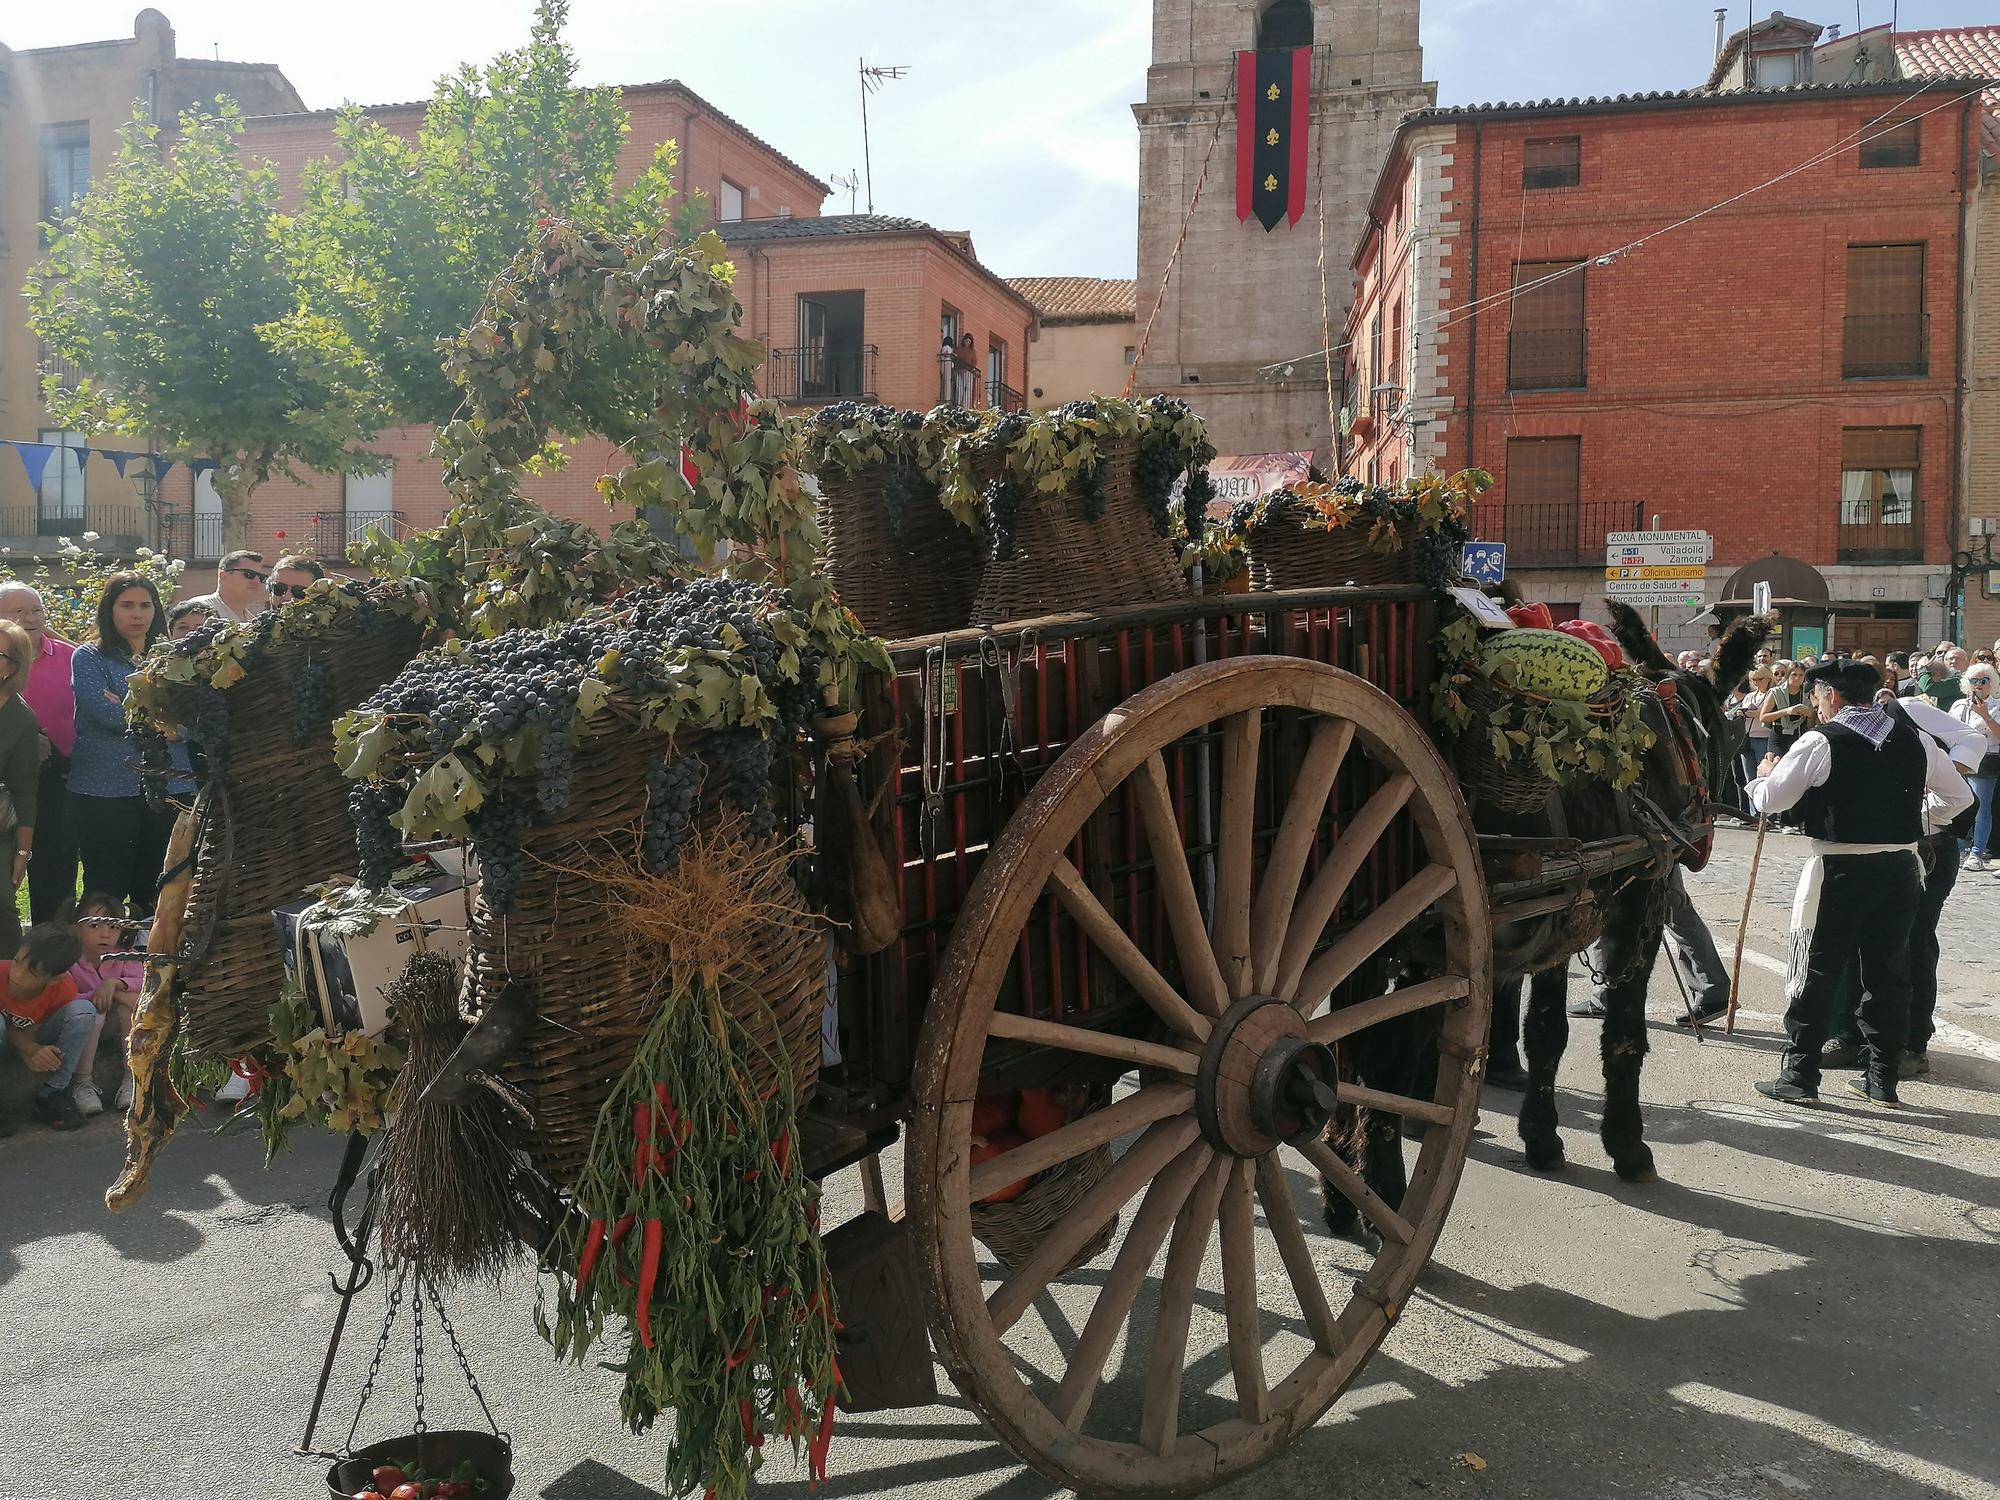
270, 866, 468, 1036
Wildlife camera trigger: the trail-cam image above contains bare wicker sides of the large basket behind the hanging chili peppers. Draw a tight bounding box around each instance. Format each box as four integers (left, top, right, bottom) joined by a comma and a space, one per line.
470, 726, 826, 1188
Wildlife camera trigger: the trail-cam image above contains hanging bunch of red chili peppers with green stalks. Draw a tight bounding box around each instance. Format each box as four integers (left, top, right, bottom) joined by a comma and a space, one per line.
536, 992, 840, 1500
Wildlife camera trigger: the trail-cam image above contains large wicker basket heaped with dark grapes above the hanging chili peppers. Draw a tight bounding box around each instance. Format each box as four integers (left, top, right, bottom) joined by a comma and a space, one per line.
338, 578, 824, 1186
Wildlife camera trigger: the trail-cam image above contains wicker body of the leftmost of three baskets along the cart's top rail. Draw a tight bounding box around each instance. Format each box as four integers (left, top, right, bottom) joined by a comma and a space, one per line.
820, 468, 982, 640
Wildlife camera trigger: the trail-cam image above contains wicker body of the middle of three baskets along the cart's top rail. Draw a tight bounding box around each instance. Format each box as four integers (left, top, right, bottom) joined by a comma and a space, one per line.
972, 438, 1188, 624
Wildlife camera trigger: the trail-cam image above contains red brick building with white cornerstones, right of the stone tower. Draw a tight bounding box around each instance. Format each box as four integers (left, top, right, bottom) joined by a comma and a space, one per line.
1342, 78, 1980, 648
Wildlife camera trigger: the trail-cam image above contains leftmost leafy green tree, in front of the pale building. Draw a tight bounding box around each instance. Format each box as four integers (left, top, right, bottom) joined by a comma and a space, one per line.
26, 104, 386, 540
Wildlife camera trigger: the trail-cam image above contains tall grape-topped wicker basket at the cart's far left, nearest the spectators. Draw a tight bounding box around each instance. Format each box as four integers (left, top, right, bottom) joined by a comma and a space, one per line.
126, 578, 428, 1060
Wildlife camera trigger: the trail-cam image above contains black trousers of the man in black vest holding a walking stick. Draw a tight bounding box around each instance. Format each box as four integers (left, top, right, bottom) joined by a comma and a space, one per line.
1778, 852, 1922, 1090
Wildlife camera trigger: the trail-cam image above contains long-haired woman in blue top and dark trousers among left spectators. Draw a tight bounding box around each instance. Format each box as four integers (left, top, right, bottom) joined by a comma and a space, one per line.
70, 572, 194, 916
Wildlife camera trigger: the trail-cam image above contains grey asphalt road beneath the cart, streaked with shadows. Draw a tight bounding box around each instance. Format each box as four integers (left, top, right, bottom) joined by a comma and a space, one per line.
0, 832, 2000, 1500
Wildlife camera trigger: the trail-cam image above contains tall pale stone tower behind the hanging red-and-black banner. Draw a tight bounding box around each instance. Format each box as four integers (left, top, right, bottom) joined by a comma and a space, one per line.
1134, 0, 1438, 462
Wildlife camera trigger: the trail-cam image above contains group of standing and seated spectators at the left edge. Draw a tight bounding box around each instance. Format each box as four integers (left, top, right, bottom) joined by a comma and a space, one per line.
0, 552, 326, 1134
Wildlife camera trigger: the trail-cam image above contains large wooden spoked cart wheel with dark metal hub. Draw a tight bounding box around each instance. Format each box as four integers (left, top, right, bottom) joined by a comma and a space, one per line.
908, 656, 1490, 1494
